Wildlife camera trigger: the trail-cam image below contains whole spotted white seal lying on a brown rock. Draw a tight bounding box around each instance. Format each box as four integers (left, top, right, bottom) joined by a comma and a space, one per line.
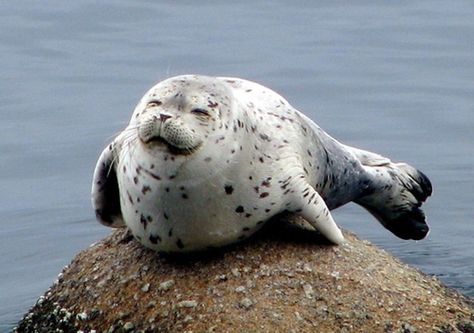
92, 75, 432, 252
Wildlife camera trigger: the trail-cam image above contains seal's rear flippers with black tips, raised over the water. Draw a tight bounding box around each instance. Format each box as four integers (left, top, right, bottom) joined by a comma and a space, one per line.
355, 155, 432, 240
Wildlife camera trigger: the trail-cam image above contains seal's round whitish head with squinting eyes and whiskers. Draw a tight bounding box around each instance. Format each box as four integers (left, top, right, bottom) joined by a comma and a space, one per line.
130, 75, 232, 155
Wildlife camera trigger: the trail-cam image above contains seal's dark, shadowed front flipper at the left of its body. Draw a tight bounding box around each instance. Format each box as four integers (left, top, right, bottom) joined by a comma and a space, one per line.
92, 144, 125, 228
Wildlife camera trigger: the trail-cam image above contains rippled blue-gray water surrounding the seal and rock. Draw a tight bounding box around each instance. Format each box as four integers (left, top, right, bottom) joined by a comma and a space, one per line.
0, 0, 474, 331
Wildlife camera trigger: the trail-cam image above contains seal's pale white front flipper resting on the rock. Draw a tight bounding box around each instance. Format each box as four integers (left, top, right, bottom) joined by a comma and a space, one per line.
291, 184, 344, 244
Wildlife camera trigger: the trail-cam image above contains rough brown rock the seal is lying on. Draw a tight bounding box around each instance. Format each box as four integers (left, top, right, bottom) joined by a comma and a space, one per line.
16, 215, 474, 333
